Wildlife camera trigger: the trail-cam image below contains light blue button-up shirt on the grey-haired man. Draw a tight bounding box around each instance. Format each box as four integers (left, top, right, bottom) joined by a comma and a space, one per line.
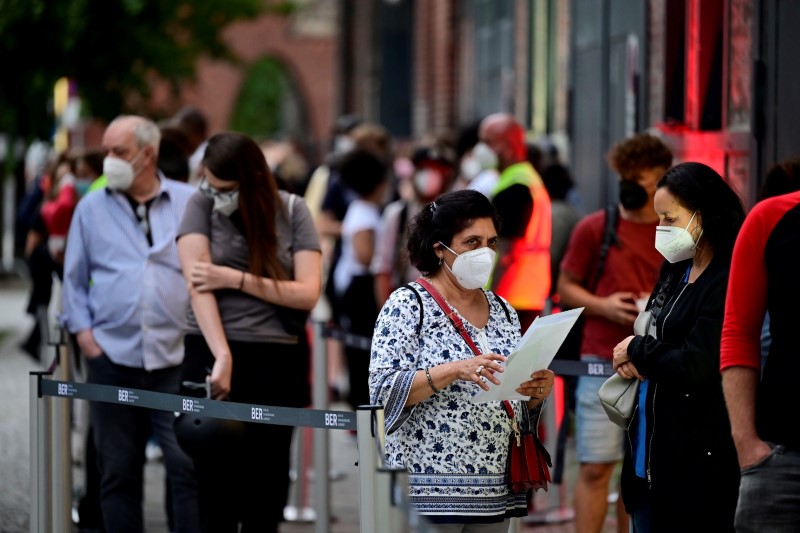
61, 176, 196, 370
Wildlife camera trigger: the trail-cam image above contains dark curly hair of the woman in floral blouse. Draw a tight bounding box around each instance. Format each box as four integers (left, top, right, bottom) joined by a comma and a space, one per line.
408, 189, 500, 274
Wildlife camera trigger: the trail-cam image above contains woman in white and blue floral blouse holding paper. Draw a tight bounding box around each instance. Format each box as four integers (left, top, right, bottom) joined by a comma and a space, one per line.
369, 190, 554, 532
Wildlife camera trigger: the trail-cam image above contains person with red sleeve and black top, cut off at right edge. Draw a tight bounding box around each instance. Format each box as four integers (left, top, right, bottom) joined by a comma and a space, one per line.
720, 192, 800, 532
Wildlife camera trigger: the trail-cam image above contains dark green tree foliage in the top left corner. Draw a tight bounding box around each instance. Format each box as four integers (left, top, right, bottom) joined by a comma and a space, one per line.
0, 0, 274, 139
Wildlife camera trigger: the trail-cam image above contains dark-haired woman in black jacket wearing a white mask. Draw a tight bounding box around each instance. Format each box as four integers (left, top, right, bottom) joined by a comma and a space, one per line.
614, 163, 745, 533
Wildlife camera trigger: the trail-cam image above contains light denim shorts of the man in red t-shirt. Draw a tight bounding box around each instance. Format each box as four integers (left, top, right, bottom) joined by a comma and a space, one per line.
575, 356, 625, 463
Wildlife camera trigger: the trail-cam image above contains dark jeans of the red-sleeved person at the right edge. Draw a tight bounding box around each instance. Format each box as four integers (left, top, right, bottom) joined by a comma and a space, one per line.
734, 442, 800, 533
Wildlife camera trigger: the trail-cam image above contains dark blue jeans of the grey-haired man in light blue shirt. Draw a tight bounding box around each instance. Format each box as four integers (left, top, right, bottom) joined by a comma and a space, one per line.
87, 355, 200, 533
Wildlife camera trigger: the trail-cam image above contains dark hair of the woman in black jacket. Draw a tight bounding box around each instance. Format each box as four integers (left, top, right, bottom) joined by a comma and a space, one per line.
657, 163, 745, 259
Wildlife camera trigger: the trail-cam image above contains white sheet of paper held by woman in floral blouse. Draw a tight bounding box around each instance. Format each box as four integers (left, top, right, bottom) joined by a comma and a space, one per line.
472, 307, 584, 403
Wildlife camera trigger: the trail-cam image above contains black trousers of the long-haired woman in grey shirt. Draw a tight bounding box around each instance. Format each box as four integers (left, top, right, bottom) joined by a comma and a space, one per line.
182, 335, 310, 533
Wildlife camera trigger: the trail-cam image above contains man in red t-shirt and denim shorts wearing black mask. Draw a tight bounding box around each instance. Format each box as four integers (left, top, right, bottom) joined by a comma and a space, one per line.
558, 135, 672, 533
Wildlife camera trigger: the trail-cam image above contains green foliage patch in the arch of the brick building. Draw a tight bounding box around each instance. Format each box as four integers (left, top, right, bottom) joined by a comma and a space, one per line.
231, 58, 287, 138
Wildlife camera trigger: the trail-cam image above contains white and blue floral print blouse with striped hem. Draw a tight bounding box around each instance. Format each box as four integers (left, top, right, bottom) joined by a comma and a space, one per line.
369, 282, 529, 523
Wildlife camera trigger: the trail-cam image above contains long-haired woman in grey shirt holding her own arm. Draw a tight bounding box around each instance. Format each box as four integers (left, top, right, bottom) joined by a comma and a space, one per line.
175, 132, 322, 533
